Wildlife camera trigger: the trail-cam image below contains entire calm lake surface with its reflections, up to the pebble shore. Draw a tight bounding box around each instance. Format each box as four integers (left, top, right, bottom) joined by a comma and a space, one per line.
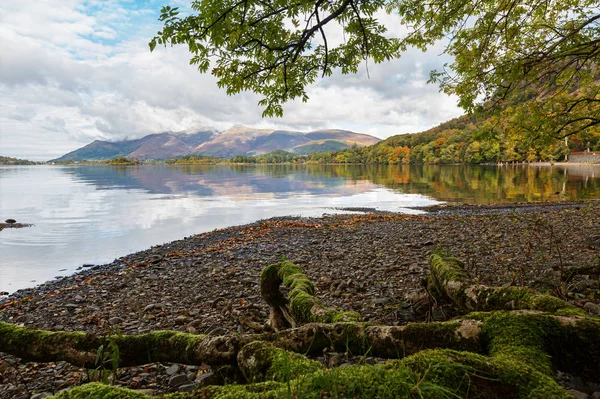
0, 165, 600, 292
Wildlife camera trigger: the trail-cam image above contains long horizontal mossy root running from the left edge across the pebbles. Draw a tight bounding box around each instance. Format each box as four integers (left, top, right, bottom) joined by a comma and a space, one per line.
0, 319, 482, 368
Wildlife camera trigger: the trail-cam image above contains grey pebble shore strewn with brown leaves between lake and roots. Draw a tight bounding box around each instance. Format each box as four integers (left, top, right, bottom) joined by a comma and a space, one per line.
0, 202, 600, 399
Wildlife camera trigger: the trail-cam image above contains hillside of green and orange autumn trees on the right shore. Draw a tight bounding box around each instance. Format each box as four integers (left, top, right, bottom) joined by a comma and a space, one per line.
308, 109, 600, 164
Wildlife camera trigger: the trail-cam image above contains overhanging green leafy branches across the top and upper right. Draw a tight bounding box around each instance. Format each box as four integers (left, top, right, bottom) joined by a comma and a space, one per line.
150, 0, 600, 141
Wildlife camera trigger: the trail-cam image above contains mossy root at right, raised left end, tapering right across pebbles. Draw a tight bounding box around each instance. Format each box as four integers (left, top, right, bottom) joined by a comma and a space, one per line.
427, 253, 585, 315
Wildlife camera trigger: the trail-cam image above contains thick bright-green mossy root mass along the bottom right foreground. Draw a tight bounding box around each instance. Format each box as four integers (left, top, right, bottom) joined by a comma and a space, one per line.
45, 311, 600, 399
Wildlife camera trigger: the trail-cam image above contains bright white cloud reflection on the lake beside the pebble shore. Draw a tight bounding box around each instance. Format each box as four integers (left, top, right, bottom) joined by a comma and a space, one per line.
0, 167, 435, 291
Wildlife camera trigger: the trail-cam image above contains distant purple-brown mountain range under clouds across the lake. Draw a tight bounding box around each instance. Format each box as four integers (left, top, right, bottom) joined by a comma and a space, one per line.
52, 125, 380, 162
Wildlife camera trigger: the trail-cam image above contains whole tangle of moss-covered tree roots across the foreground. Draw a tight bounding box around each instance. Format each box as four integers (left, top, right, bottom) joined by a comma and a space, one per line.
0, 255, 600, 399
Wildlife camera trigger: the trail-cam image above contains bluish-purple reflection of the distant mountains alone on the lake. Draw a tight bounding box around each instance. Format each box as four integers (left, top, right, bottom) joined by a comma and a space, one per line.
64, 165, 375, 198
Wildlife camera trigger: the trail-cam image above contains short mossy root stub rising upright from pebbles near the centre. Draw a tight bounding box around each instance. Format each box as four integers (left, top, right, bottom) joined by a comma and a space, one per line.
260, 259, 361, 331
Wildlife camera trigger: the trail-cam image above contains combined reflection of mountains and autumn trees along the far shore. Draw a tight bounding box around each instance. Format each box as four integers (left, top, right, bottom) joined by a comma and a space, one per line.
64, 165, 600, 204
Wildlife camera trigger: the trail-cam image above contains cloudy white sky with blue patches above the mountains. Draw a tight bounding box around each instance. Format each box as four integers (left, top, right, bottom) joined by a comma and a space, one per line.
0, 0, 462, 160
